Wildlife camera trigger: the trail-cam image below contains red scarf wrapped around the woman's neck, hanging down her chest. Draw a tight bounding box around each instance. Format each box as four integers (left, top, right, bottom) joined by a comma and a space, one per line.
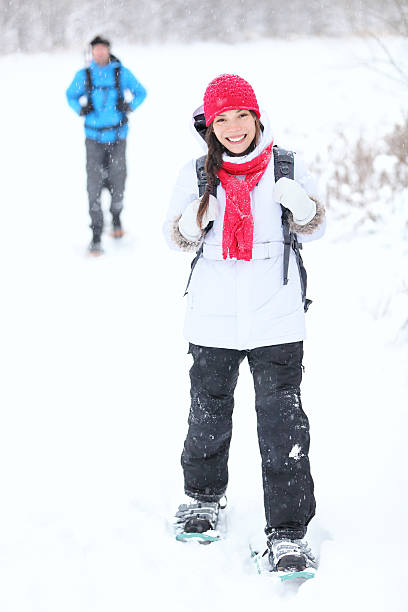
218, 142, 273, 261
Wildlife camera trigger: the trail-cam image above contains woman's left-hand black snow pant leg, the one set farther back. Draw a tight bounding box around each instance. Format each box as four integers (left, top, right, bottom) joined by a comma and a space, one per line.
181, 344, 245, 501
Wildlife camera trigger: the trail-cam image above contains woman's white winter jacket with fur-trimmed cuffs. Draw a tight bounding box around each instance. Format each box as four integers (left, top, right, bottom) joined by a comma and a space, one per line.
164, 114, 325, 350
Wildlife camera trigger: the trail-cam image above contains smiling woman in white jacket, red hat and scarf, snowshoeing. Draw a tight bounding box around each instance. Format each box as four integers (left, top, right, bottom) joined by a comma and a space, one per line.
165, 75, 325, 571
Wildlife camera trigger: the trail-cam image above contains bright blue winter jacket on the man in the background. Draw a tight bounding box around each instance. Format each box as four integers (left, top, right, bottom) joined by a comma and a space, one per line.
67, 61, 146, 142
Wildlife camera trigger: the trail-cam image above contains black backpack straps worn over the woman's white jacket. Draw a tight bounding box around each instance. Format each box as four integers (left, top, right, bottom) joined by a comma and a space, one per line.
184, 145, 312, 312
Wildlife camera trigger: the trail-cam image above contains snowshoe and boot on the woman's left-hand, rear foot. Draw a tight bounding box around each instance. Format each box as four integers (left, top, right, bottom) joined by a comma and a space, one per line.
174, 498, 226, 544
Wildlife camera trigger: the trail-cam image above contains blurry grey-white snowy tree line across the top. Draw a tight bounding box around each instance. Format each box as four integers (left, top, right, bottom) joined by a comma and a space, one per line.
0, 0, 407, 53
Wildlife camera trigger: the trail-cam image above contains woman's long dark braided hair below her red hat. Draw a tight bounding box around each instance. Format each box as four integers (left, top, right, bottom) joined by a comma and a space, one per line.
197, 111, 262, 227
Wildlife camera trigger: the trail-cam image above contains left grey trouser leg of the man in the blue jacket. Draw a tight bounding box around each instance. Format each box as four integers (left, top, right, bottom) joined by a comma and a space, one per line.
85, 138, 106, 236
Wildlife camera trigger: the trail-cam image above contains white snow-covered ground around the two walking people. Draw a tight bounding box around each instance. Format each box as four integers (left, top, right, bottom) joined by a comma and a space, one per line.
0, 40, 408, 612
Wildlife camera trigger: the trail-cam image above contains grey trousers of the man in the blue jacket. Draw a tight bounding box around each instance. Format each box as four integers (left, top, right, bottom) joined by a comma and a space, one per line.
85, 138, 126, 236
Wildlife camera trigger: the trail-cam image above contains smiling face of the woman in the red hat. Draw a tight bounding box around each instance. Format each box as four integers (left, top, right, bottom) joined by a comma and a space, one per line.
213, 110, 256, 155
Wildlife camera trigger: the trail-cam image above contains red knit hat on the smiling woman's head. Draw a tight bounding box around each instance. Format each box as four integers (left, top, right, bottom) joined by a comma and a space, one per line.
204, 74, 261, 126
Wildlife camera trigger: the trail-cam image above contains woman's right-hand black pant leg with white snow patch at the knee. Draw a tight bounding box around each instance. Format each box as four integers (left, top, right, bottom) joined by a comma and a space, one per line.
248, 342, 315, 538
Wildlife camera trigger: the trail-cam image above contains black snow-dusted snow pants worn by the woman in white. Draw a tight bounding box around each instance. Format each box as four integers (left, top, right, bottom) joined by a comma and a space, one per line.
181, 342, 315, 539
